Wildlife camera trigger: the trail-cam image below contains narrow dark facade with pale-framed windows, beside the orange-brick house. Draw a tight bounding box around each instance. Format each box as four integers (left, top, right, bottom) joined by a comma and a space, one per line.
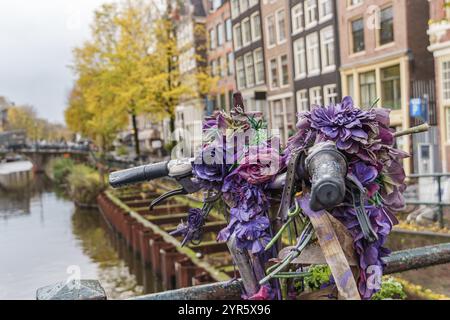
230, 0, 268, 117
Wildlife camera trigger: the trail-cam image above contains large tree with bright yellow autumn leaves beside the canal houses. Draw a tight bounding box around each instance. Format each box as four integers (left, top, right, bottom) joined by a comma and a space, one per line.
65, 0, 214, 156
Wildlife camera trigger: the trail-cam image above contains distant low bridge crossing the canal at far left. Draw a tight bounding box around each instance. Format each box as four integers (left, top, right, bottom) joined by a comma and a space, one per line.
0, 148, 90, 172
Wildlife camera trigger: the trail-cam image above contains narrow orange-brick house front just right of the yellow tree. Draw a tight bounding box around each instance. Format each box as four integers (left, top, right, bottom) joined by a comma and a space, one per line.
205, 0, 236, 113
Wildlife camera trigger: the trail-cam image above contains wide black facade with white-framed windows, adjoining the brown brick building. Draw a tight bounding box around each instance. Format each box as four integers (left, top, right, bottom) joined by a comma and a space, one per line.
289, 0, 342, 122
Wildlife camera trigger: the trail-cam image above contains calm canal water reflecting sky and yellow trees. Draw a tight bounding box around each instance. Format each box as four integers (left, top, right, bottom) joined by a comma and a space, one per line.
0, 176, 450, 300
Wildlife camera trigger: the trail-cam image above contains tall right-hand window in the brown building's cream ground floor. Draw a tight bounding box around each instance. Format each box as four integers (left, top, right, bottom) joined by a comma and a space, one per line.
381, 66, 402, 110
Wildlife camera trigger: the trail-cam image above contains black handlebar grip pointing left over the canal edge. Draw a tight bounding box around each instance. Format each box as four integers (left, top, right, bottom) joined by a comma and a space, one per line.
109, 161, 169, 188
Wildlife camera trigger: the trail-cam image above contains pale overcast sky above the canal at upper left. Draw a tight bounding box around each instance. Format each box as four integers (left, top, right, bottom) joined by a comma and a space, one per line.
0, 0, 111, 123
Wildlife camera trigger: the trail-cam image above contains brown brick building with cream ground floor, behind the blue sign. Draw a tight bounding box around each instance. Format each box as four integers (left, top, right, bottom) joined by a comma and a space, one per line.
337, 0, 439, 173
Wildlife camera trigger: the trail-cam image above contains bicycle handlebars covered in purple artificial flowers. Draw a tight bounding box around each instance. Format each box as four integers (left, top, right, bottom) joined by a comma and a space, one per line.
110, 93, 427, 299
